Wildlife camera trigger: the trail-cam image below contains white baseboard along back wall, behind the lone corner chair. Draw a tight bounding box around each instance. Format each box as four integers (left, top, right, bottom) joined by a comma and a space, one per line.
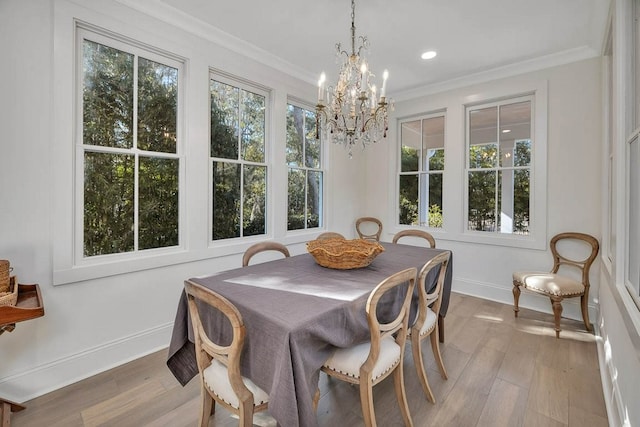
451, 277, 598, 323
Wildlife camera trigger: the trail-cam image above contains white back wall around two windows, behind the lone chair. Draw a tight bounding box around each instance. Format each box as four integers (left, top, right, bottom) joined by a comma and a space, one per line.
366, 58, 602, 321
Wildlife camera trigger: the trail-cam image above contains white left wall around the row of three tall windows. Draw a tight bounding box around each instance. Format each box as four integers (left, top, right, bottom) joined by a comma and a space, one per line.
0, 0, 362, 402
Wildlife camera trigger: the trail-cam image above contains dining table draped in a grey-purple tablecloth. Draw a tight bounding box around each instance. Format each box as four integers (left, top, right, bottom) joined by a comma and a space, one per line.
167, 243, 453, 427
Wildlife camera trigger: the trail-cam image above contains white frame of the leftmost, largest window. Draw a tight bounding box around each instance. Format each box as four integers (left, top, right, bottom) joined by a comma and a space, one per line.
72, 25, 186, 267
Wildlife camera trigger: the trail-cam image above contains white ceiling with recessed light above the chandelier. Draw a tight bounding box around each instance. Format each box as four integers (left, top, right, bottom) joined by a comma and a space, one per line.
138, 0, 609, 96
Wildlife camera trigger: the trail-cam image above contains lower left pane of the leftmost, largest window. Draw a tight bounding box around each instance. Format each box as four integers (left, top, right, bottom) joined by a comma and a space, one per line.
84, 152, 134, 257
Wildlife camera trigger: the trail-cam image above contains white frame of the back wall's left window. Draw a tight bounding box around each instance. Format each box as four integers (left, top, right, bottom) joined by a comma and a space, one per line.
394, 109, 447, 232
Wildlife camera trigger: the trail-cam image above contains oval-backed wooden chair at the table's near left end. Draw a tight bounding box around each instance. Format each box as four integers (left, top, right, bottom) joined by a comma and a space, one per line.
184, 280, 269, 427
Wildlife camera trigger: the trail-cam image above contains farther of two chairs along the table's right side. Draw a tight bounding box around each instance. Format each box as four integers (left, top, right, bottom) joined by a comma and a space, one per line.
410, 251, 451, 403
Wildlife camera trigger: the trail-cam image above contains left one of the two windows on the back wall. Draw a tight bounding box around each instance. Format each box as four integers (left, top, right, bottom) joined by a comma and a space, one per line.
398, 114, 445, 227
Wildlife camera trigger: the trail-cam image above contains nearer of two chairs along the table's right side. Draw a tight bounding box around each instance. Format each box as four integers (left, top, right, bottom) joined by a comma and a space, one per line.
322, 268, 417, 427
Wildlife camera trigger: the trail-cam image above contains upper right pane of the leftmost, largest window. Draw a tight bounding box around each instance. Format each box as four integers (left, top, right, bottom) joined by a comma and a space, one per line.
138, 58, 178, 153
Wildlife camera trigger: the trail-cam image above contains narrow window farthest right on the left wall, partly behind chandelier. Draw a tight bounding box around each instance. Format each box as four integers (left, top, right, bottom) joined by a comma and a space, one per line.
286, 104, 323, 230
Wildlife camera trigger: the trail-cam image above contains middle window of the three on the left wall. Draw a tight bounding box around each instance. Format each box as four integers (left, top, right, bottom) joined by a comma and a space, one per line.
210, 75, 268, 240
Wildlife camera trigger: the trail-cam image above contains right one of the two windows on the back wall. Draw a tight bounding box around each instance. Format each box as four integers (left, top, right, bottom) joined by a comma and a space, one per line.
466, 97, 533, 235
